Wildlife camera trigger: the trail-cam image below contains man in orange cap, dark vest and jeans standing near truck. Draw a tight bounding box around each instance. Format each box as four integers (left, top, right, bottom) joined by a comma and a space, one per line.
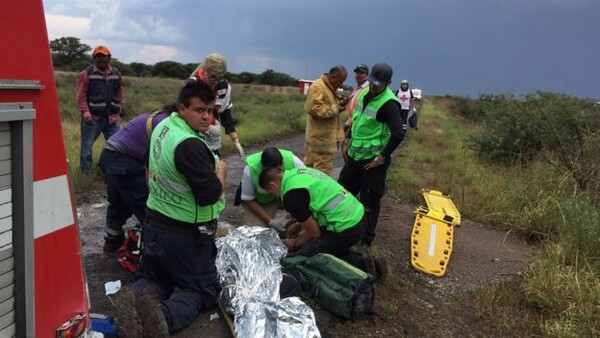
76, 46, 124, 174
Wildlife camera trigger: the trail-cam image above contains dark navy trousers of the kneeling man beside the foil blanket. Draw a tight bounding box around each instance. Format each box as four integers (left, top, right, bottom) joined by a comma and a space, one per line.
133, 215, 217, 332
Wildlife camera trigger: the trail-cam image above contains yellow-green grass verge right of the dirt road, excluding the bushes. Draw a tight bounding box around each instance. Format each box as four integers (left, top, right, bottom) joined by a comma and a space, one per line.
388, 98, 600, 337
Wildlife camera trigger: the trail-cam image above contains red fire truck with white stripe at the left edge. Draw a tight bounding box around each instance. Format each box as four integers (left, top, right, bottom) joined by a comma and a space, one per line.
0, 0, 90, 338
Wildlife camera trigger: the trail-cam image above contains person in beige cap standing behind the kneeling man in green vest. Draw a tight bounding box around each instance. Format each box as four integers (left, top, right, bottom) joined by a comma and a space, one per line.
190, 53, 245, 157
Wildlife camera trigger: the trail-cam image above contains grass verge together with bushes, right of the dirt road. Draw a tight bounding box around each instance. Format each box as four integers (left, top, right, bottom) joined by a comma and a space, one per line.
389, 93, 600, 337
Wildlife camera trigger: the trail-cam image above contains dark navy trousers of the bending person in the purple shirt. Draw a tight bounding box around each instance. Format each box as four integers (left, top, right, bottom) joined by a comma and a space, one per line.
98, 148, 149, 237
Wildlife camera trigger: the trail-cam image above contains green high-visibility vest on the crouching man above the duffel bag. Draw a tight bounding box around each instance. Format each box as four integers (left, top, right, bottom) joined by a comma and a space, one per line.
281, 168, 365, 232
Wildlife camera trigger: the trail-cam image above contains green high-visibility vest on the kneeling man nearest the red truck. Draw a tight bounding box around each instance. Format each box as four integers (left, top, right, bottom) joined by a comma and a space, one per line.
146, 113, 225, 223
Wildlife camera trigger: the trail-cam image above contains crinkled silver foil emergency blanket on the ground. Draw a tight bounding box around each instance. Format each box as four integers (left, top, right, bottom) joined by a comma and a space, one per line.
216, 226, 321, 338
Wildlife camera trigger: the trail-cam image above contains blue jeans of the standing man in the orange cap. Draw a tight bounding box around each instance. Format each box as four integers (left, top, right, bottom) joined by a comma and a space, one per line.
79, 116, 119, 174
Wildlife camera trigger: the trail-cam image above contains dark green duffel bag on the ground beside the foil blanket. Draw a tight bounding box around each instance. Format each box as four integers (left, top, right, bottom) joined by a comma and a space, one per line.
281, 254, 375, 319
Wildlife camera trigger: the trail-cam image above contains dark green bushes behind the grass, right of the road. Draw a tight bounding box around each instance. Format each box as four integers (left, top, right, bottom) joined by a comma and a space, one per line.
455, 92, 600, 199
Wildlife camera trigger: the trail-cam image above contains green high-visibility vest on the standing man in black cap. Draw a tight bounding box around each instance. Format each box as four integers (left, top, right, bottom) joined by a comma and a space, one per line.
348, 87, 398, 161
